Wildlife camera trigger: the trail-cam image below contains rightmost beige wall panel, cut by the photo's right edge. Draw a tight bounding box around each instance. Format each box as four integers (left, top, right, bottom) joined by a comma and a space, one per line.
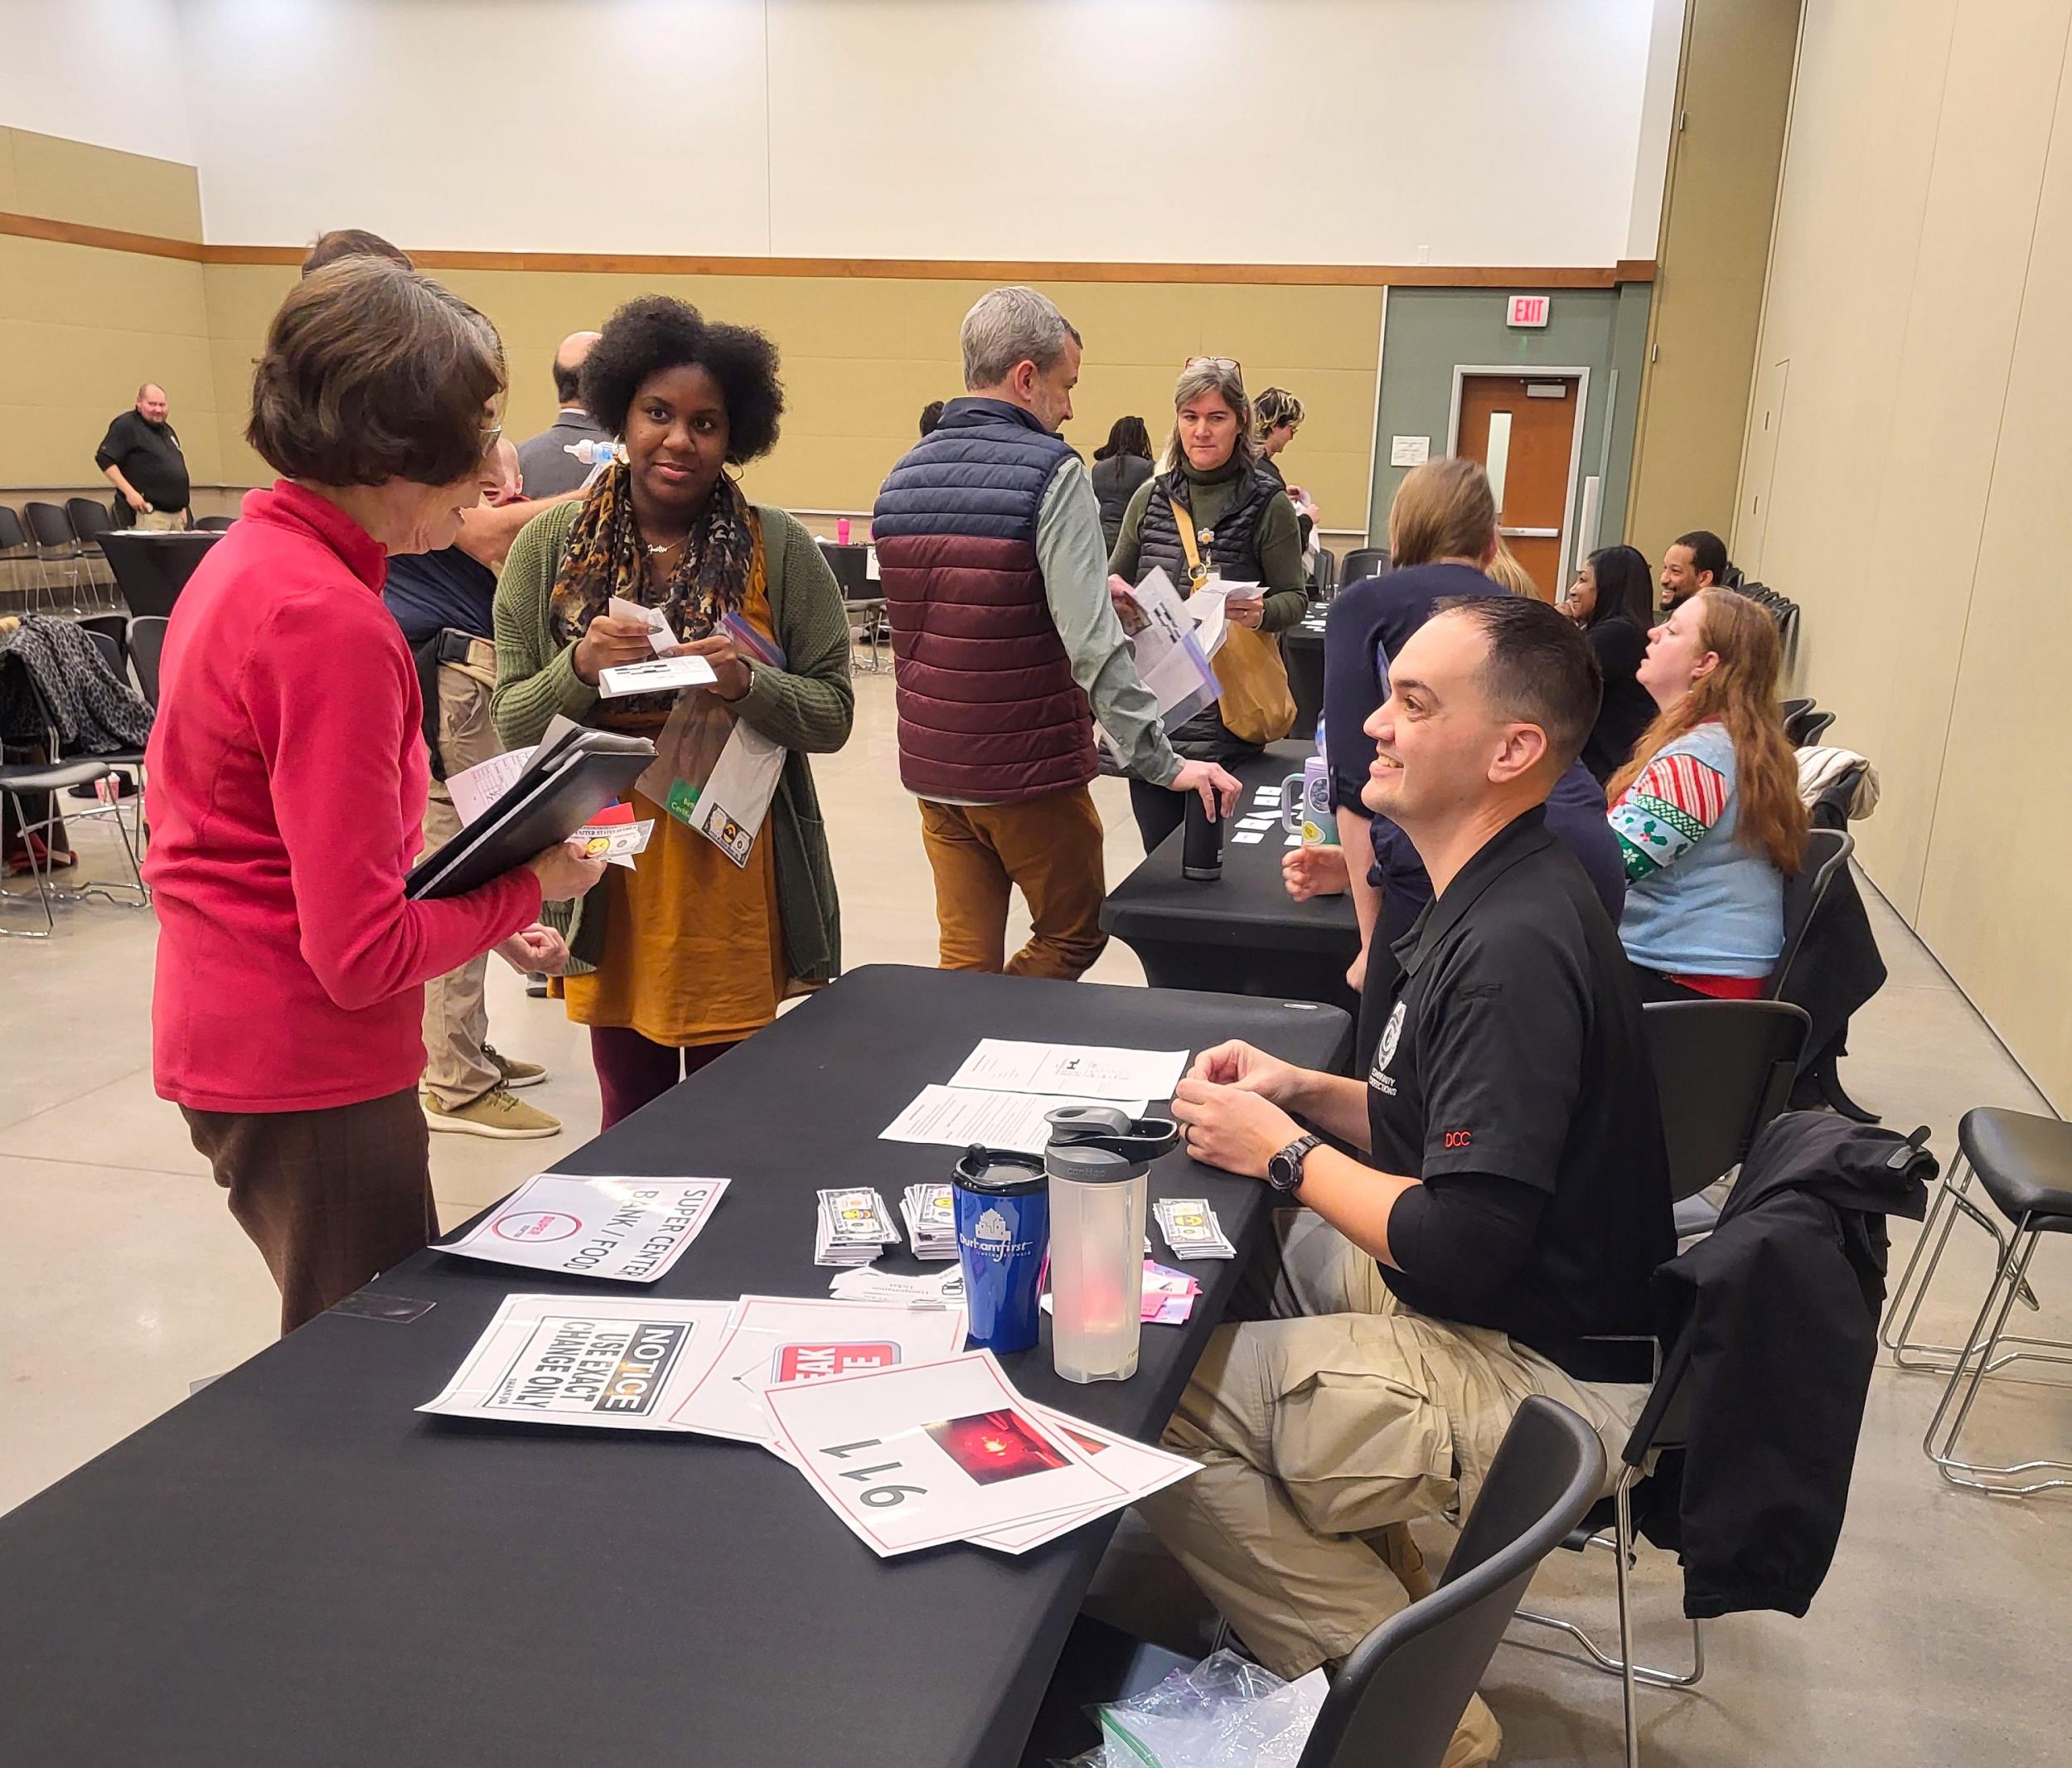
1919, 41, 2072, 1107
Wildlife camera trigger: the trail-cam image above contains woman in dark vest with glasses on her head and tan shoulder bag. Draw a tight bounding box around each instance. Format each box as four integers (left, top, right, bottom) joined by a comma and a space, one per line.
1109, 356, 1308, 852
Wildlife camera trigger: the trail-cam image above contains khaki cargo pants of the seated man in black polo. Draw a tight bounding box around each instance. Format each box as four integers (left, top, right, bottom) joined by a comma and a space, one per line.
1140, 1210, 1648, 1683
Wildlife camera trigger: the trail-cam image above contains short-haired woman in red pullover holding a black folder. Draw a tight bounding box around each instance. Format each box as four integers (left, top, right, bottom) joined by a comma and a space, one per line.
145, 257, 603, 1333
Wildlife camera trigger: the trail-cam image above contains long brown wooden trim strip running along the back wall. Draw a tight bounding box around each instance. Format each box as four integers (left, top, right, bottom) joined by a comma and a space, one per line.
0, 211, 1656, 288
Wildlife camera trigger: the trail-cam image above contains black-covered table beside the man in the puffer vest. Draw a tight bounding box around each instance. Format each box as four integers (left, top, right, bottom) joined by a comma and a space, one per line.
1101, 740, 1366, 1014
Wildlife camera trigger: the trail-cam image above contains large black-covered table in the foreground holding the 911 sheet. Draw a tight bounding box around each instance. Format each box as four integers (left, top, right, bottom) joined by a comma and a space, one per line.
0, 966, 1351, 1768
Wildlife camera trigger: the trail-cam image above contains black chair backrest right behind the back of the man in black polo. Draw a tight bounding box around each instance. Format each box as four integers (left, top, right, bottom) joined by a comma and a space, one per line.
1641, 1001, 1813, 1202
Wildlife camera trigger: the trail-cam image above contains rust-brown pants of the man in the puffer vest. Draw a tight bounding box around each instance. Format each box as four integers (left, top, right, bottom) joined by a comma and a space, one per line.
920, 786, 1109, 982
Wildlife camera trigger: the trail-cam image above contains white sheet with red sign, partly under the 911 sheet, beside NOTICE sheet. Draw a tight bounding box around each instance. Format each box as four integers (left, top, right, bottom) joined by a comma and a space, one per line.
670, 1296, 966, 1445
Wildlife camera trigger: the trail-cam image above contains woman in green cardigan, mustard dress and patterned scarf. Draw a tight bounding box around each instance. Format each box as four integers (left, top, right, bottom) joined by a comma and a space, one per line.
491, 294, 856, 1130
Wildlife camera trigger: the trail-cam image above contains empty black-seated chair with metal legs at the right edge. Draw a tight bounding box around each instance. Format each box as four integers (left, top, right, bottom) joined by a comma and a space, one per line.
1881, 1107, 2072, 1499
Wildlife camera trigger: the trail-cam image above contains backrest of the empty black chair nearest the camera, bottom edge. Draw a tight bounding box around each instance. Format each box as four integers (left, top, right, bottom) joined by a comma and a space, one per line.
1297, 1395, 1604, 1768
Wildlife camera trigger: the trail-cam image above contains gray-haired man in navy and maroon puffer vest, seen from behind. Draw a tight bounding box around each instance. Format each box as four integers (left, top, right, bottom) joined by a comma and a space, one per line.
870, 288, 1237, 981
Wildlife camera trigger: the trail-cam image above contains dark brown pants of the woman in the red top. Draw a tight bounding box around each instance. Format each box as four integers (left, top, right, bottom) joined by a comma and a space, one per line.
181, 1088, 439, 1333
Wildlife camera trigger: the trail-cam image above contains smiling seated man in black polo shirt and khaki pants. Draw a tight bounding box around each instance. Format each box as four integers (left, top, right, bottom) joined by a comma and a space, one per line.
1144, 597, 1674, 1768
